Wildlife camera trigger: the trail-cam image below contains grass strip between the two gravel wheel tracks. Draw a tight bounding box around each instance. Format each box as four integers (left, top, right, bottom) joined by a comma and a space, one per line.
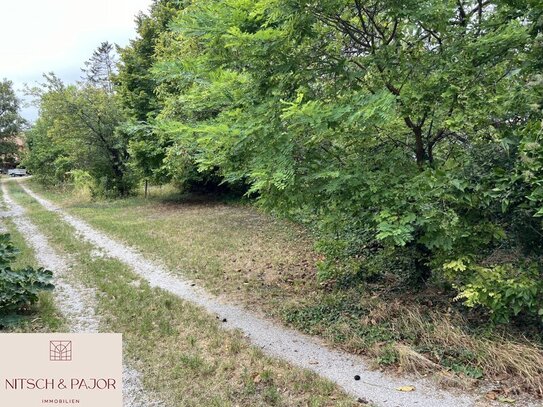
10, 184, 360, 407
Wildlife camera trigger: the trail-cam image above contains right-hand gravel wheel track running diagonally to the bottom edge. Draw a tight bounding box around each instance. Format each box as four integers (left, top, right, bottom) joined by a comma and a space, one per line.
17, 185, 484, 407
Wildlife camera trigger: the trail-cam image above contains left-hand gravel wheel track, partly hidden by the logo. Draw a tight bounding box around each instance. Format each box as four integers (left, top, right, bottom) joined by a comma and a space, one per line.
0, 183, 163, 407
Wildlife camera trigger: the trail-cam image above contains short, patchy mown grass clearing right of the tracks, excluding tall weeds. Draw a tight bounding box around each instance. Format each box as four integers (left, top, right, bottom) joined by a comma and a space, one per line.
27, 180, 318, 310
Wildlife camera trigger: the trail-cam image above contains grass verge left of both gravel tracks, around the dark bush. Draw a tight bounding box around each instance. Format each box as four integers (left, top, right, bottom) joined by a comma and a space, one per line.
0, 186, 66, 333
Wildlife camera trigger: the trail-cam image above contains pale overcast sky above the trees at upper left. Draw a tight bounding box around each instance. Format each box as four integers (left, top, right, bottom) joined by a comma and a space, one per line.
0, 0, 152, 120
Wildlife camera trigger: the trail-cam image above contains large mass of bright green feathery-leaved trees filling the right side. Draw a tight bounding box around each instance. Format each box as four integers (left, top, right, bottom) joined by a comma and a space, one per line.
24, 0, 543, 321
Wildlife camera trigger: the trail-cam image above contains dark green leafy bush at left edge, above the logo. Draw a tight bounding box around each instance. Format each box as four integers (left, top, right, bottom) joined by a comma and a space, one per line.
0, 234, 54, 325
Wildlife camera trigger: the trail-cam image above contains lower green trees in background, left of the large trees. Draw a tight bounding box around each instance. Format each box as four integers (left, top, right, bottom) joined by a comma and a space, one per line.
24, 43, 133, 195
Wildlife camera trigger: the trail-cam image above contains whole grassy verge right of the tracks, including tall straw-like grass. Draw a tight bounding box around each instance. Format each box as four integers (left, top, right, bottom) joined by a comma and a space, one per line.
25, 184, 543, 395
